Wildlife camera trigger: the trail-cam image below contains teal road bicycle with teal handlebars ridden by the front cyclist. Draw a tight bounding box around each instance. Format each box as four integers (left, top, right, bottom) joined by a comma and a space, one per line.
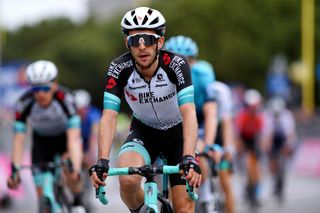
96, 156, 198, 213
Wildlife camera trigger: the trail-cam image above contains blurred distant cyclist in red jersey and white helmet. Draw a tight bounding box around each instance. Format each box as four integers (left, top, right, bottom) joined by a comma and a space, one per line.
236, 89, 264, 206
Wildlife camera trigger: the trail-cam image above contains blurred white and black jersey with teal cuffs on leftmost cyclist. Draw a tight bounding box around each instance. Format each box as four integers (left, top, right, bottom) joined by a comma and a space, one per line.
14, 87, 81, 136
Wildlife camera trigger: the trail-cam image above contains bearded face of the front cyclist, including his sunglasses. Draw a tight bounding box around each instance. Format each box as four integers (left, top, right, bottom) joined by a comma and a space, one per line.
126, 30, 164, 68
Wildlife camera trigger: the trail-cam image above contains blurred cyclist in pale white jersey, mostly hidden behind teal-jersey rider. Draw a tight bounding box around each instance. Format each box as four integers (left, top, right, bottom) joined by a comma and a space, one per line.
211, 81, 235, 213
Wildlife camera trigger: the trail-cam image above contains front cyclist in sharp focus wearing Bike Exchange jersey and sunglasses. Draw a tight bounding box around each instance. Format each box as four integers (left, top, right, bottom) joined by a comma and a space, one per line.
89, 7, 201, 212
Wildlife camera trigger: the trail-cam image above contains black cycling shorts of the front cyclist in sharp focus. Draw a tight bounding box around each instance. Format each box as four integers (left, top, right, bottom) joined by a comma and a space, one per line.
122, 118, 186, 187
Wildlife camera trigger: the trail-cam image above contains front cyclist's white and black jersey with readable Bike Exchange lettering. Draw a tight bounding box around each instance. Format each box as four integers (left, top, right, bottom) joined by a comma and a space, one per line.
104, 50, 194, 130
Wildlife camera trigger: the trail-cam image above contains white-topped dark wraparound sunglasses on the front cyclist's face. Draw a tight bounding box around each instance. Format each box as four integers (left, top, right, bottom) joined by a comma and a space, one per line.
127, 33, 160, 47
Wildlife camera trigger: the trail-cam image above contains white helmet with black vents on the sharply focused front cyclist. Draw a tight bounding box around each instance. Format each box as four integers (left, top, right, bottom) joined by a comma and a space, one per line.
121, 7, 166, 36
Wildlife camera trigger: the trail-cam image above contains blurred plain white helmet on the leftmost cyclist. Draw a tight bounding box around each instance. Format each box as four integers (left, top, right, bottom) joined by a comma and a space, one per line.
26, 60, 58, 85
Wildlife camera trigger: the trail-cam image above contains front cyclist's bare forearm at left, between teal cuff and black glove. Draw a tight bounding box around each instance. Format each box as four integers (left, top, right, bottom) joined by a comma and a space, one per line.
98, 110, 117, 159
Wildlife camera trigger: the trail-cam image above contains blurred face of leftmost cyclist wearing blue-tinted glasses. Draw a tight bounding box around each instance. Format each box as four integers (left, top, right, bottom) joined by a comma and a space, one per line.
32, 83, 57, 107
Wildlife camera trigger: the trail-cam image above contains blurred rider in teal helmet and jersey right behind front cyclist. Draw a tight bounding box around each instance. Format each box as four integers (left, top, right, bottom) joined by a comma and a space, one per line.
165, 35, 234, 213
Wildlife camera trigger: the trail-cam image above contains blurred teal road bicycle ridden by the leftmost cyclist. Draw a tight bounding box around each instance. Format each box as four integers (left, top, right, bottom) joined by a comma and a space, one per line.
13, 156, 73, 213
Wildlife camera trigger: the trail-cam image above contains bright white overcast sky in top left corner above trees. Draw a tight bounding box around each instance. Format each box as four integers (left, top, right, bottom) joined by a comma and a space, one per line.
0, 0, 89, 30
